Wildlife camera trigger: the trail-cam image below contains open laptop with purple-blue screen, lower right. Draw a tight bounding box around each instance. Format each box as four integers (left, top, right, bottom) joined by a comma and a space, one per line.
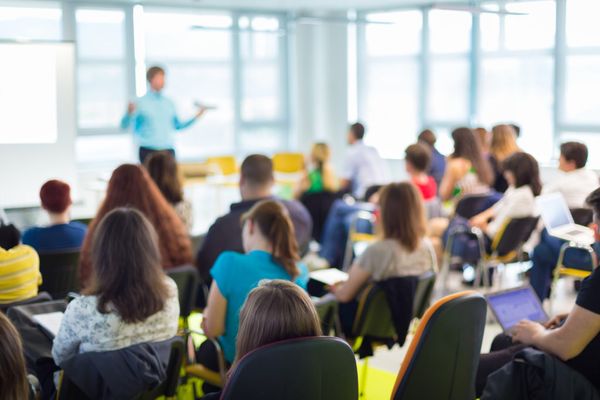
485, 285, 550, 334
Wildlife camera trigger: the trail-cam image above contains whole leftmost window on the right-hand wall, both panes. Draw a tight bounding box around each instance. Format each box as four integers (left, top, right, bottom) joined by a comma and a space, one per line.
359, 11, 422, 158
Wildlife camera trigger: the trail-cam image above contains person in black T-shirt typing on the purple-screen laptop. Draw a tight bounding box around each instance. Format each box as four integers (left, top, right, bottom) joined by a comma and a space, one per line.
477, 189, 600, 395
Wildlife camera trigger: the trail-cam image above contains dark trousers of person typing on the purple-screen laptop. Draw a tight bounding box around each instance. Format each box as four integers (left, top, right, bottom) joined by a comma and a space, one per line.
475, 333, 527, 398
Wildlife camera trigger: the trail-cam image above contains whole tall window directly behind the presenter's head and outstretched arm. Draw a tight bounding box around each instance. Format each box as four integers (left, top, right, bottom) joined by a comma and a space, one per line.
143, 7, 235, 159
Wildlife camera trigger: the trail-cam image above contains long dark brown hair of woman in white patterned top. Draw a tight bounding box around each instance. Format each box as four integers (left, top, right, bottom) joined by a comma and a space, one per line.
89, 208, 167, 323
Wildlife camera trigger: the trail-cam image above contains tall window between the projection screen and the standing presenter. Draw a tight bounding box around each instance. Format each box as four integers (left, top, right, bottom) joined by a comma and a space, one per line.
75, 8, 128, 132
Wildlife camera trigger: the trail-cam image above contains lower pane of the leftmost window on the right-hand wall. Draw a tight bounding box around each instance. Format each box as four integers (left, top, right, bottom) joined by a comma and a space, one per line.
361, 60, 419, 158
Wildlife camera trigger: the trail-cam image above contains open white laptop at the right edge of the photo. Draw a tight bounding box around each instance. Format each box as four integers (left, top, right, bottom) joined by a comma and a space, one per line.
536, 193, 594, 245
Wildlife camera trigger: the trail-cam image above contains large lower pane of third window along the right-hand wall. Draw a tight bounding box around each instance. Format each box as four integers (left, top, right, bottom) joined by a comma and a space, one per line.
478, 56, 553, 161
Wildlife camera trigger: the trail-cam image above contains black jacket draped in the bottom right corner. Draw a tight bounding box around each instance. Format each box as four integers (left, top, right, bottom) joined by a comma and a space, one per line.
481, 347, 600, 400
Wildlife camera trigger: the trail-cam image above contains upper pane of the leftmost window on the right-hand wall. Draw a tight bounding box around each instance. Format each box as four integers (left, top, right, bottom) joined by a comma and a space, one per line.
365, 11, 423, 57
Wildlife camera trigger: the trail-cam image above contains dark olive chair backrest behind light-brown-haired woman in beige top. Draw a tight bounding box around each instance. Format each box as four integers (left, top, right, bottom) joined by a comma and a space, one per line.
352, 284, 396, 339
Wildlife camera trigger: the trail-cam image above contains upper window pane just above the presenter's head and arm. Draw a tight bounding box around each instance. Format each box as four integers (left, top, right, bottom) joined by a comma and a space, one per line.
143, 9, 231, 60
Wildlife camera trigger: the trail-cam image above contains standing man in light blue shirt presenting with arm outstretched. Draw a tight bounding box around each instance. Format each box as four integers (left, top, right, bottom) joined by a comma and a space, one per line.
121, 66, 207, 164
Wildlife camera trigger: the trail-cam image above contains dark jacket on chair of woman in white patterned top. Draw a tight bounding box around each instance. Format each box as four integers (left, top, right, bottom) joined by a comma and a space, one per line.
61, 338, 180, 400
